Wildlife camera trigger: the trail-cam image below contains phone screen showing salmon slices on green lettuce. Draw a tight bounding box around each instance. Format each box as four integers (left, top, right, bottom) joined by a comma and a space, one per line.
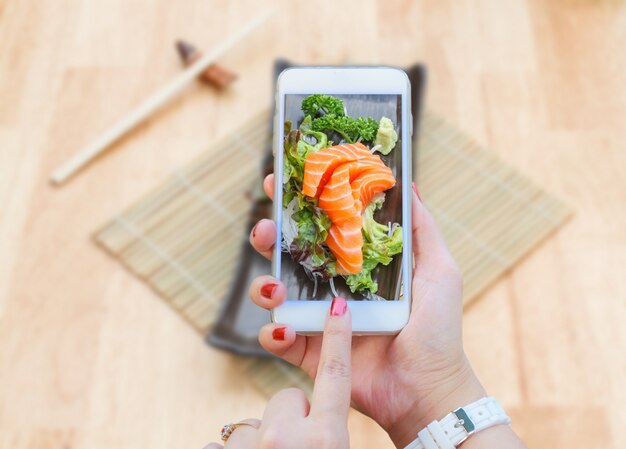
277, 94, 404, 301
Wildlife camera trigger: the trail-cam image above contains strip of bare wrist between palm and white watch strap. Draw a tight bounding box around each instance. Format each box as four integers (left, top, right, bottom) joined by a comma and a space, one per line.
386, 359, 487, 449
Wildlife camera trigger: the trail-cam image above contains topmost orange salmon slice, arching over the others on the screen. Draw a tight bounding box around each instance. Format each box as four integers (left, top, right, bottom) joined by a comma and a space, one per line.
302, 143, 384, 198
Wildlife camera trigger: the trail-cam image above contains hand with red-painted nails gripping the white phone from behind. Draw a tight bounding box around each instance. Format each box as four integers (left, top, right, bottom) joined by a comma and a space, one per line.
250, 175, 485, 447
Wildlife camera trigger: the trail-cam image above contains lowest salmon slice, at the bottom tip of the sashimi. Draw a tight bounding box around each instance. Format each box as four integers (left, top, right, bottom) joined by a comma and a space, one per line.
326, 215, 363, 275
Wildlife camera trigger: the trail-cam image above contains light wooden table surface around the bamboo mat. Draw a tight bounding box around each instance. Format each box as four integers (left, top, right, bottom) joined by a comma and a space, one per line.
0, 0, 626, 449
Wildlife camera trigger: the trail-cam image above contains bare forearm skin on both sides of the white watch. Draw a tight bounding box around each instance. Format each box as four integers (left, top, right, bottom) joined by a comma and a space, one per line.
387, 365, 526, 449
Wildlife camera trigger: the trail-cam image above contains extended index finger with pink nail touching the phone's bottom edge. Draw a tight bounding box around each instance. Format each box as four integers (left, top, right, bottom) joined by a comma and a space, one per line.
311, 297, 352, 420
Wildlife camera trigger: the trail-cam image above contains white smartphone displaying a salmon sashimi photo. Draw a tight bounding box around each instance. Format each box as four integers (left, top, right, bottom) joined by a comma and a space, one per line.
271, 67, 413, 334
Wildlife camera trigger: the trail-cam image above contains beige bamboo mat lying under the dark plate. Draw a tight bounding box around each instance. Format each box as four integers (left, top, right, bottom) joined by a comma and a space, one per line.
95, 111, 570, 394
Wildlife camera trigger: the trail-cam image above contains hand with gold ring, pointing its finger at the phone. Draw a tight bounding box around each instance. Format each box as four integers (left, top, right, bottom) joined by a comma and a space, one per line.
205, 298, 352, 449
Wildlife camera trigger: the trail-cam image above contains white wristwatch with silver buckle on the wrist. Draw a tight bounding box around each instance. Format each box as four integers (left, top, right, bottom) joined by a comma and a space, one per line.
404, 397, 511, 449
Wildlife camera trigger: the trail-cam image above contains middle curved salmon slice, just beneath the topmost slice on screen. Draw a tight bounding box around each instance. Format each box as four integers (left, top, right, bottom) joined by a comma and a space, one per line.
318, 158, 386, 223
